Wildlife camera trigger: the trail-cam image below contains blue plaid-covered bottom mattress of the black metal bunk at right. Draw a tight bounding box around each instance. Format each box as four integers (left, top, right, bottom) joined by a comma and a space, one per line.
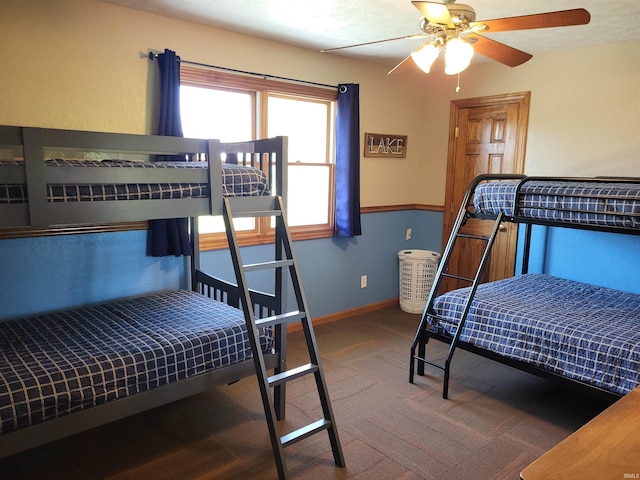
429, 274, 640, 395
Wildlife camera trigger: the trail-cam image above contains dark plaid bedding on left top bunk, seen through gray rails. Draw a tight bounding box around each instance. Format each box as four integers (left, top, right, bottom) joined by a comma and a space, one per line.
0, 160, 269, 204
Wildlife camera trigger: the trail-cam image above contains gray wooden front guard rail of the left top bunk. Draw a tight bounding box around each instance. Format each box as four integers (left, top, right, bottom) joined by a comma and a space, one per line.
0, 127, 222, 227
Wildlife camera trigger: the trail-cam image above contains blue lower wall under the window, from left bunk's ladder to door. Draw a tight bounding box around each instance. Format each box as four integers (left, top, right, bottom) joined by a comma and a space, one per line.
201, 210, 442, 317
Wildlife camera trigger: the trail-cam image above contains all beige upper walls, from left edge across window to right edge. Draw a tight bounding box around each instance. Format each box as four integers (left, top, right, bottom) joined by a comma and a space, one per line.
0, 0, 640, 206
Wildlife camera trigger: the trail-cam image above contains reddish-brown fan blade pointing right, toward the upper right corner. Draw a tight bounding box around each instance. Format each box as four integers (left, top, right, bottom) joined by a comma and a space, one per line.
475, 8, 591, 32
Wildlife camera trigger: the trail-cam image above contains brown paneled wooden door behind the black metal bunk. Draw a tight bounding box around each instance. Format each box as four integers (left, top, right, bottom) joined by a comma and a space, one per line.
441, 92, 530, 292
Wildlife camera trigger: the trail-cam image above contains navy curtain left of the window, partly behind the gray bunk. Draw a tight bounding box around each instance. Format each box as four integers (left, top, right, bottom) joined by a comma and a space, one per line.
149, 49, 192, 257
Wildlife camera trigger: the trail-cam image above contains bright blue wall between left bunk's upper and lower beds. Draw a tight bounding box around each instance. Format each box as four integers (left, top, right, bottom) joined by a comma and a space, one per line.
0, 231, 187, 319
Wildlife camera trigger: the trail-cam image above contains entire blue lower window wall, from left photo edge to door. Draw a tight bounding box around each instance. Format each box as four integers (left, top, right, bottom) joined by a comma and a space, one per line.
0, 210, 442, 319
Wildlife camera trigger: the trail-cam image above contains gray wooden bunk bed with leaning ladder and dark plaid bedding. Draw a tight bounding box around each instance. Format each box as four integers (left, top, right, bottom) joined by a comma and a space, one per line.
0, 127, 344, 478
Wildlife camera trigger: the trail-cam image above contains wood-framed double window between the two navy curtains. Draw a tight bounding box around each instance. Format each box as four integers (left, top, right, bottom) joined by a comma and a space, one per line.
180, 66, 337, 249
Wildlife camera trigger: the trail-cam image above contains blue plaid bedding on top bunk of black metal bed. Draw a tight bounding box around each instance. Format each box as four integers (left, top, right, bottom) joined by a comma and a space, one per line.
474, 180, 640, 228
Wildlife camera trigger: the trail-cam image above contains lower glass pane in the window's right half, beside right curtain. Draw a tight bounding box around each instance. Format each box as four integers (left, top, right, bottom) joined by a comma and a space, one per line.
287, 164, 329, 227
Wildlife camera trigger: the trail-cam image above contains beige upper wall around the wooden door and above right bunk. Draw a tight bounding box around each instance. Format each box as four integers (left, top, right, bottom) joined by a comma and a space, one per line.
424, 37, 640, 202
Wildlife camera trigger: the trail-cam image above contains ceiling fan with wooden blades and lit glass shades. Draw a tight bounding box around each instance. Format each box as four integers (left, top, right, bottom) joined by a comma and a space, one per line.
321, 0, 591, 75
